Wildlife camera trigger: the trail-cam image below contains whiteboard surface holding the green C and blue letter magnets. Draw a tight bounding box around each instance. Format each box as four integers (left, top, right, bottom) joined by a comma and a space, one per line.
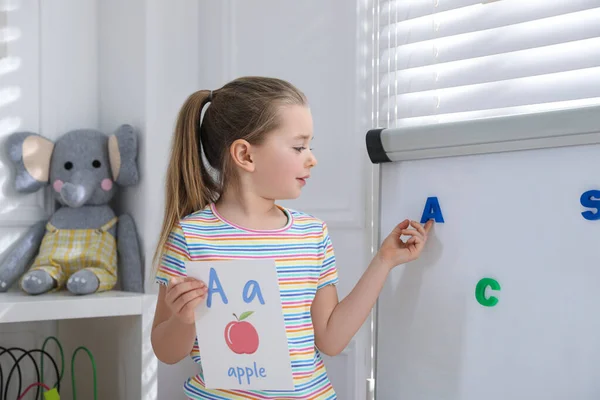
375, 145, 600, 400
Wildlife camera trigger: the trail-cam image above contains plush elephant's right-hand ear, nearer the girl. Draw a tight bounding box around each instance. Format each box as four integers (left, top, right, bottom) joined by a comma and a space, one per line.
108, 125, 139, 186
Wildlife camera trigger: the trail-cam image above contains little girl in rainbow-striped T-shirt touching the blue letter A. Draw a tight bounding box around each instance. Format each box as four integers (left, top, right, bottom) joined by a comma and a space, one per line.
152, 77, 432, 399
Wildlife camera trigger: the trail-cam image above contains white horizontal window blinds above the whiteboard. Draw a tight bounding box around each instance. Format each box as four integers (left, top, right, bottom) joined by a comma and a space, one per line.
374, 0, 600, 128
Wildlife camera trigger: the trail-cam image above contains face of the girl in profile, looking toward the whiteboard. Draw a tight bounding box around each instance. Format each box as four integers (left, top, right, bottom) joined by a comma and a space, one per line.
252, 105, 317, 200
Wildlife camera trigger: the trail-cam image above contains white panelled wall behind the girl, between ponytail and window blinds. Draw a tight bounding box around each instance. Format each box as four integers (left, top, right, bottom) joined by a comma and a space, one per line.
159, 0, 371, 399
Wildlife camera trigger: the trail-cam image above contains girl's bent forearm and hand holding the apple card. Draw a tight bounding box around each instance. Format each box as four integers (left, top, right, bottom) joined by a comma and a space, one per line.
151, 278, 206, 364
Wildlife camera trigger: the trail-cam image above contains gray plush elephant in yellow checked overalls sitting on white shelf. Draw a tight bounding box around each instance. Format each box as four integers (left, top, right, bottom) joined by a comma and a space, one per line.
0, 125, 143, 295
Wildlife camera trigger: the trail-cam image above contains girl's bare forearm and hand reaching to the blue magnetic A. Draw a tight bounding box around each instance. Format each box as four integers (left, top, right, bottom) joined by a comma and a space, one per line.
311, 220, 433, 356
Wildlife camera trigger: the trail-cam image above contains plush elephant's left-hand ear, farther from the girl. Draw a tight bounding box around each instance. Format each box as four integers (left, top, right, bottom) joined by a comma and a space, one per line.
6, 132, 54, 193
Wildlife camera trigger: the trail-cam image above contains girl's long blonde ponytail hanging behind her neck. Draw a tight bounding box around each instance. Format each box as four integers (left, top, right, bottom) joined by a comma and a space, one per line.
153, 90, 218, 266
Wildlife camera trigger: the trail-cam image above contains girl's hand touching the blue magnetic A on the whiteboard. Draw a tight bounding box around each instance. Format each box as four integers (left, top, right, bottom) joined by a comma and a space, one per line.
377, 220, 433, 269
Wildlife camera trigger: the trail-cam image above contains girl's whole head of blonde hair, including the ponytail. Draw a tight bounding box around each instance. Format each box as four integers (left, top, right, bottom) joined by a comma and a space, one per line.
153, 77, 307, 265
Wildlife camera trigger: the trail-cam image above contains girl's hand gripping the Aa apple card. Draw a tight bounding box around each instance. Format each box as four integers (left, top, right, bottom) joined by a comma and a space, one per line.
165, 277, 208, 324
